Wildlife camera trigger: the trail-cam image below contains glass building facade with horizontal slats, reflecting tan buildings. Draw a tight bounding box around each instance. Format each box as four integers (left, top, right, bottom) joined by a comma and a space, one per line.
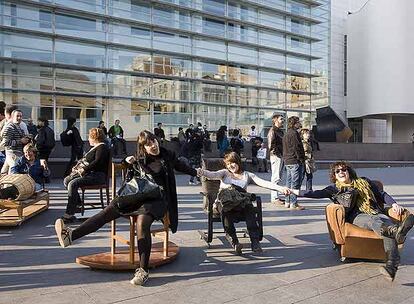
0, 0, 330, 140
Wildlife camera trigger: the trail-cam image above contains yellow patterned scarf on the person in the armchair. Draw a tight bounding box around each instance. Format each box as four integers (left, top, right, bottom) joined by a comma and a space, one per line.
335, 178, 378, 215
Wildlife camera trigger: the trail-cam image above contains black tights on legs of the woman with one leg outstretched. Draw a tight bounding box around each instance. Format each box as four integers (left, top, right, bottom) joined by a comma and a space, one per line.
72, 198, 154, 271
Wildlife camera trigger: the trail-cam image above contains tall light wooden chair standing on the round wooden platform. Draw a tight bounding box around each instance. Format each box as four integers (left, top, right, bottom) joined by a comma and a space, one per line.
111, 163, 170, 264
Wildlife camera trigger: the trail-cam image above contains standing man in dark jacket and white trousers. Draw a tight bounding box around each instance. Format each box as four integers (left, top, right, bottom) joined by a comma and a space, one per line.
267, 114, 286, 205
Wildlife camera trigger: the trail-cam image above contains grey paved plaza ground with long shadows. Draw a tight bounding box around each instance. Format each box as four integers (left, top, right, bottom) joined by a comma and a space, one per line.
0, 168, 414, 304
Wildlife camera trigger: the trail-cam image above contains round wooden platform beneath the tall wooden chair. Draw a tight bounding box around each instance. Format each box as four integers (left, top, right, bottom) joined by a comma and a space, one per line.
76, 242, 180, 270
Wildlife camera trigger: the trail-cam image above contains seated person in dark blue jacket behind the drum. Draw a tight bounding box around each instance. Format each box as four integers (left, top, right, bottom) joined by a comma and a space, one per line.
0, 144, 50, 199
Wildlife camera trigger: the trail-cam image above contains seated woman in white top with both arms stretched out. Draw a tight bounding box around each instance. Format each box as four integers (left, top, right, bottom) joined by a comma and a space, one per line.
197, 152, 288, 255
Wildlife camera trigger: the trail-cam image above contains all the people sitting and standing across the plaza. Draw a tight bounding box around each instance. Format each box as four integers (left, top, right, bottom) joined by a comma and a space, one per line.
0, 104, 414, 285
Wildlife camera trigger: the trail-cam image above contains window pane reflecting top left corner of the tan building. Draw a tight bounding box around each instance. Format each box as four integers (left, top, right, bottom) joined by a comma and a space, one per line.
108, 49, 151, 73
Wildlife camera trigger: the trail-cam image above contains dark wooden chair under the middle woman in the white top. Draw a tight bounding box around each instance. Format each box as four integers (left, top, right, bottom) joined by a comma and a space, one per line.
198, 158, 263, 247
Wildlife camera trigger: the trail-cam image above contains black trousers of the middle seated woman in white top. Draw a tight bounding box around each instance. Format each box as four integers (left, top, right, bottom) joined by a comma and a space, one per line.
221, 204, 260, 245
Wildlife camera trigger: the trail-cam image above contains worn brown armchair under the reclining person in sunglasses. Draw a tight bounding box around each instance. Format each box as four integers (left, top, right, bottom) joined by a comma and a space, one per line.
326, 182, 410, 262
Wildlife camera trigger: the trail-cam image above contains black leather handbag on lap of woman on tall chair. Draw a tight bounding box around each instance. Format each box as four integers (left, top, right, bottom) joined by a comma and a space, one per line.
118, 162, 164, 203
